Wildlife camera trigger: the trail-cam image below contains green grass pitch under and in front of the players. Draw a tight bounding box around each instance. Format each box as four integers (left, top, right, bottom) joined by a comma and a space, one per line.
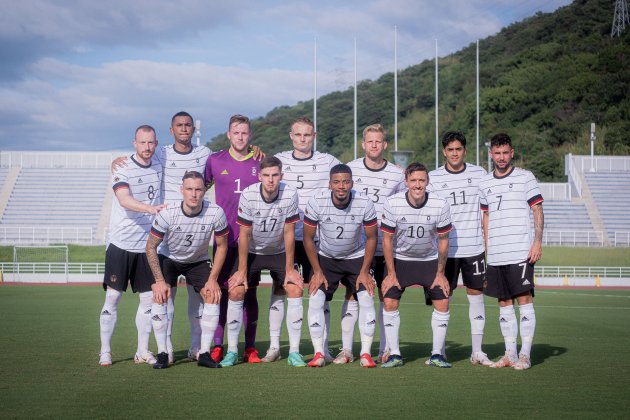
0, 285, 630, 418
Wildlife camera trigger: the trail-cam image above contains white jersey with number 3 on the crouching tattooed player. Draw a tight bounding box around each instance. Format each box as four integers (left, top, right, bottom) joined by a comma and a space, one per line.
151, 200, 228, 263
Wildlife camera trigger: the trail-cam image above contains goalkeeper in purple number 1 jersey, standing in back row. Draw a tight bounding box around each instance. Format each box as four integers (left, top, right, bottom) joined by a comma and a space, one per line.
205, 115, 260, 363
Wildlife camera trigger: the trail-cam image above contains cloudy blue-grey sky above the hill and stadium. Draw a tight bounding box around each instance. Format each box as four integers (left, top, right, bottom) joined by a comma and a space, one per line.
0, 0, 570, 150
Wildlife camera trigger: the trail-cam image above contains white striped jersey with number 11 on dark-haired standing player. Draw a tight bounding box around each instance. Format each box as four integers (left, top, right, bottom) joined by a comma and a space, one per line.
427, 163, 487, 258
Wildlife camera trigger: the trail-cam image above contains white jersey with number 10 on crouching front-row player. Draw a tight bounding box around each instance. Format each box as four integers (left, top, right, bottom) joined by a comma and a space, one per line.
381, 192, 452, 261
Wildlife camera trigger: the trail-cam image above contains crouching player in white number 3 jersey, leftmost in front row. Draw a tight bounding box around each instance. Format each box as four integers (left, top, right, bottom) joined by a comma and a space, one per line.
146, 171, 228, 369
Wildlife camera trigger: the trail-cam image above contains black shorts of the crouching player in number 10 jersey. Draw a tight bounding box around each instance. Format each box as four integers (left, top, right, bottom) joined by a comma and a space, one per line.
384, 258, 448, 300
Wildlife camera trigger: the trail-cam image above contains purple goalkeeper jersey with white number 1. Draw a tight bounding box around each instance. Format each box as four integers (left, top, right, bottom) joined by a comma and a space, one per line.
205, 149, 260, 246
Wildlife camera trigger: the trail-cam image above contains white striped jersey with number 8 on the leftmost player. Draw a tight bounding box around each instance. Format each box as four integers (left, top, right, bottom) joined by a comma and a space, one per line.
107, 155, 162, 252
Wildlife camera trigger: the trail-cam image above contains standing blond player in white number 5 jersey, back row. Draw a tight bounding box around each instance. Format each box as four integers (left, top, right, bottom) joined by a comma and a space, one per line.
276, 117, 341, 362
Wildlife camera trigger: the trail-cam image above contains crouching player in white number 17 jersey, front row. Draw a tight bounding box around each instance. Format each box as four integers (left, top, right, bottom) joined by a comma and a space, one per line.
221, 156, 306, 367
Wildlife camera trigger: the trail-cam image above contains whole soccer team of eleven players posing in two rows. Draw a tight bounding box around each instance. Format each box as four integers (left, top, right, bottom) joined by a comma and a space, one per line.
99, 112, 544, 370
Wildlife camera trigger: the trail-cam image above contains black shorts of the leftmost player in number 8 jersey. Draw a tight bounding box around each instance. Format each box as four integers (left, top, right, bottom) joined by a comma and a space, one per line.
103, 244, 155, 293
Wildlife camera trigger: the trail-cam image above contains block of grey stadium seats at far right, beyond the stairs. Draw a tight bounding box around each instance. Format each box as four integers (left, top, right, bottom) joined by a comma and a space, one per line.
584, 172, 630, 244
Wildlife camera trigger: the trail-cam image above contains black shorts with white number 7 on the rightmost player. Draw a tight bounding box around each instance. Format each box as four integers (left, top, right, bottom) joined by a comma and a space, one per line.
483, 261, 534, 299
